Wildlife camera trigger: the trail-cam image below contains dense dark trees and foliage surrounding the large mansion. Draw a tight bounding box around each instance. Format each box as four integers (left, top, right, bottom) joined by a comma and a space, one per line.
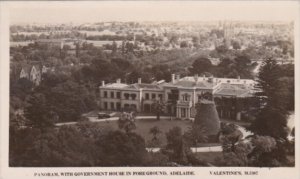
9, 30, 294, 167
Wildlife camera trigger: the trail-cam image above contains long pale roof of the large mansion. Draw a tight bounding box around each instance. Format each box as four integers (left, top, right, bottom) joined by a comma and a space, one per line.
101, 76, 256, 97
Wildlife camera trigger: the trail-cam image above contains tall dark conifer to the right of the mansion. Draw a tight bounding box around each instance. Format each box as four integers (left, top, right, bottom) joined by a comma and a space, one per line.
250, 59, 288, 139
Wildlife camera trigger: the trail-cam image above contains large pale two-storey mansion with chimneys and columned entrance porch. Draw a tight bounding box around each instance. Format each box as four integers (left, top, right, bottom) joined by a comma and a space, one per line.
98, 74, 255, 120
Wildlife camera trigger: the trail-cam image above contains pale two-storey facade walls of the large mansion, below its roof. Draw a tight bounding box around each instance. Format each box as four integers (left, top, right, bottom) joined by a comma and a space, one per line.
99, 77, 254, 119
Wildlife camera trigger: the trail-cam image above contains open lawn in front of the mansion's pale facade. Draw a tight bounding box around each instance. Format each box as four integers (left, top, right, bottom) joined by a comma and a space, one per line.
95, 119, 192, 145
